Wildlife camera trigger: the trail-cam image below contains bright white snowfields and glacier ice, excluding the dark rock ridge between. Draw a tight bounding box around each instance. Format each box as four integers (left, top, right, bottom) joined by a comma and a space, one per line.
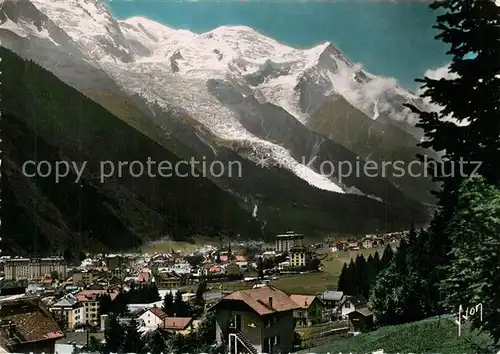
2, 0, 434, 198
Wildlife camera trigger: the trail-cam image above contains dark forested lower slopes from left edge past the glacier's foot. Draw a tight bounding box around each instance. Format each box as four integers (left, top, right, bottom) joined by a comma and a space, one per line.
0, 48, 430, 253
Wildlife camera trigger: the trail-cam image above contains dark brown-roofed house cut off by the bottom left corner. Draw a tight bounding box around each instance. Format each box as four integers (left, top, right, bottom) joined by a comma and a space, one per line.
0, 296, 64, 354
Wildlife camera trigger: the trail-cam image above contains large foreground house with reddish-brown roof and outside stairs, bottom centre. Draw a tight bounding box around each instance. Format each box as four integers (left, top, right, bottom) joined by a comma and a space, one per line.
212, 286, 300, 354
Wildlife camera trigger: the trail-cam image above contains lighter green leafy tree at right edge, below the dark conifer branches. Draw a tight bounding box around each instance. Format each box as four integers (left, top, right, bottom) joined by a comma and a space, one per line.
440, 178, 500, 342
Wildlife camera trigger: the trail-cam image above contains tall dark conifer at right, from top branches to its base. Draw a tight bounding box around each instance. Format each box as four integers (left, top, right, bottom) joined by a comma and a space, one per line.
396, 0, 500, 326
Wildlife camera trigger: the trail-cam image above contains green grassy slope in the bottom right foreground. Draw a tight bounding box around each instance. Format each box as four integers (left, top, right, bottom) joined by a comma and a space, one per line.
301, 317, 493, 354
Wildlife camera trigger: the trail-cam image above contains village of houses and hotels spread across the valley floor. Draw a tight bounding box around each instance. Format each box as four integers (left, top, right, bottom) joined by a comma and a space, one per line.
0, 231, 406, 354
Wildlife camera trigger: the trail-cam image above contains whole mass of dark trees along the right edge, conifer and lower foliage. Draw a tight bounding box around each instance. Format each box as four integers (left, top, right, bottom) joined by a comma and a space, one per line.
370, 0, 500, 346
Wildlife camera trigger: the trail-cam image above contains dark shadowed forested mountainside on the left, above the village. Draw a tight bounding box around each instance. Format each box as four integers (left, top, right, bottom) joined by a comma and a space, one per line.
0, 48, 260, 252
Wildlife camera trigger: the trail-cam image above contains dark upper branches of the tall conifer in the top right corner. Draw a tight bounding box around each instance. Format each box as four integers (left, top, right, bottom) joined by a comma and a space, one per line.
408, 0, 500, 188
